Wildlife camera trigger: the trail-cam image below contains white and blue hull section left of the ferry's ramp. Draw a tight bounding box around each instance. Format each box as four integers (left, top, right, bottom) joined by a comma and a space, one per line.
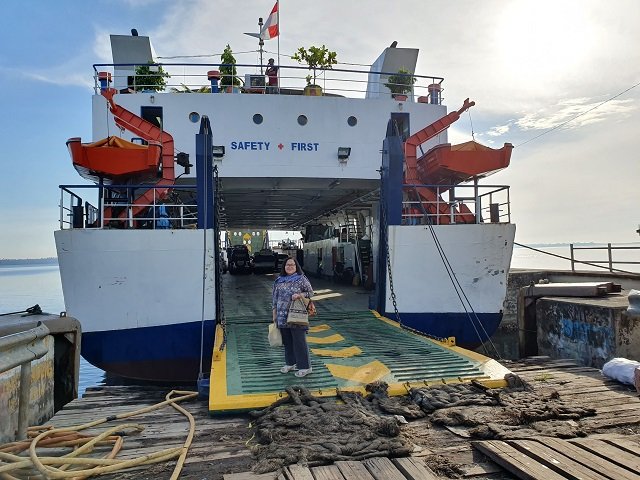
55, 229, 216, 381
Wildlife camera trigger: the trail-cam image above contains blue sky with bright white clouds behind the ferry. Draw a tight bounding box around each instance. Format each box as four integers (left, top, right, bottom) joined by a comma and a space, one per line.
0, 0, 640, 258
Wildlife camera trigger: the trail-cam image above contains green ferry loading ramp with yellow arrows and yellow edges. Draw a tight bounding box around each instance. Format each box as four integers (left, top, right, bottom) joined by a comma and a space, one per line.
209, 311, 509, 414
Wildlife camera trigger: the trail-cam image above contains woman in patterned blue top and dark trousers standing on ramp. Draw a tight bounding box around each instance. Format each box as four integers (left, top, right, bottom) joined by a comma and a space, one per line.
272, 257, 313, 377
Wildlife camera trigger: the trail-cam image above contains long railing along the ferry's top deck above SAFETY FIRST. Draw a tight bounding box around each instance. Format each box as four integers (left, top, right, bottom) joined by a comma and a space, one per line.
93, 63, 444, 105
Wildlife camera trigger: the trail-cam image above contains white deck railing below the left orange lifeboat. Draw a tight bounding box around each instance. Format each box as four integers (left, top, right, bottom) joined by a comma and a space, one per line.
59, 184, 198, 230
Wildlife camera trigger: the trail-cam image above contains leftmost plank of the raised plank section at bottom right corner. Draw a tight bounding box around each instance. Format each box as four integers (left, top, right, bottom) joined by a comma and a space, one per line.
473, 440, 566, 480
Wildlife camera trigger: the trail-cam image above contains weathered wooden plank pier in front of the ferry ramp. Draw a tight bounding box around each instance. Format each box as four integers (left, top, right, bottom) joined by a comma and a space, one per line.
6, 358, 640, 480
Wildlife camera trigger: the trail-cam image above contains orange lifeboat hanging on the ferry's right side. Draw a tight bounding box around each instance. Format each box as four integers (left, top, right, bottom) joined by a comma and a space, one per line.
416, 141, 513, 185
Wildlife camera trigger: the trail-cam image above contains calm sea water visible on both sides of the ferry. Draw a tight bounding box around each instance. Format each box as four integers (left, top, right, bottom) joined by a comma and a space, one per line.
0, 244, 640, 395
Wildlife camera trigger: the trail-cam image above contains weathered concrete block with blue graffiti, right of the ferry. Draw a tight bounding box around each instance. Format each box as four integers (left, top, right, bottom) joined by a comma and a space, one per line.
536, 293, 640, 368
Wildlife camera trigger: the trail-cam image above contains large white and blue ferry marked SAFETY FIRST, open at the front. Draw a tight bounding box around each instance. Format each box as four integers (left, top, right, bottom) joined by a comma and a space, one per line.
55, 35, 515, 382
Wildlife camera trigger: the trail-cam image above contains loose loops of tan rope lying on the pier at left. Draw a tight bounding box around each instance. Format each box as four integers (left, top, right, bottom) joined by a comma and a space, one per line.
0, 390, 198, 480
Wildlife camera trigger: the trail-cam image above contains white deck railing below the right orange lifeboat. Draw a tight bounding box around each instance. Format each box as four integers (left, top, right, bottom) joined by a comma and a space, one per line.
402, 184, 511, 225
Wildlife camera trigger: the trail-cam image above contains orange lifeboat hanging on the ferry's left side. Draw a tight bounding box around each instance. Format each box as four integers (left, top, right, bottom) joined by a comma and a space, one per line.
67, 136, 162, 184
